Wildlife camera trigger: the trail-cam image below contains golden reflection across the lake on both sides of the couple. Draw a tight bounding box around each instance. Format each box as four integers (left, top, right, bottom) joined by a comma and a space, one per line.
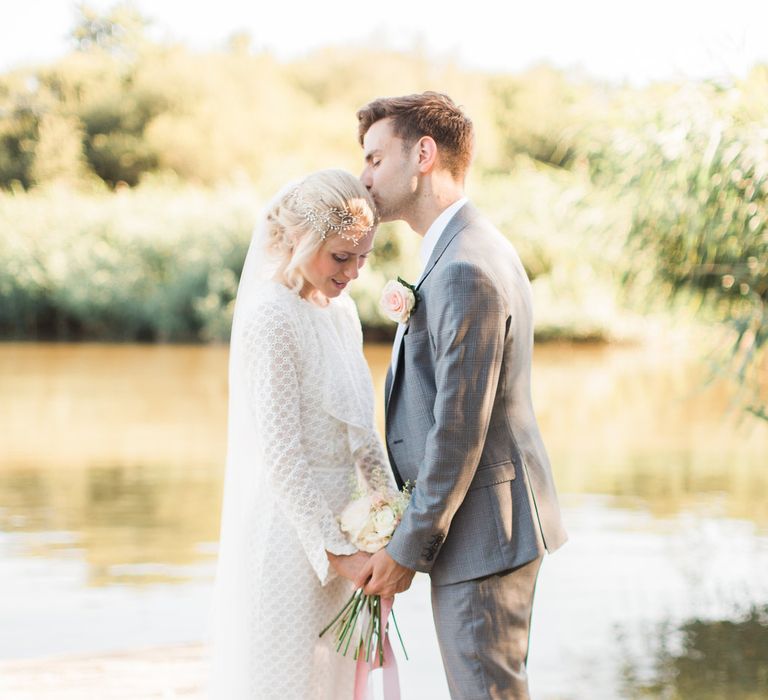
0, 344, 768, 585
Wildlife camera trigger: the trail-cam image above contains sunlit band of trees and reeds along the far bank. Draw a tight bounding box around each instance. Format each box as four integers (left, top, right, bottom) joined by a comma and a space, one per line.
0, 5, 768, 412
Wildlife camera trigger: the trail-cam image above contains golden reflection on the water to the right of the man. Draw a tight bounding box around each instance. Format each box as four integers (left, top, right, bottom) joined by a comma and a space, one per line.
534, 346, 768, 527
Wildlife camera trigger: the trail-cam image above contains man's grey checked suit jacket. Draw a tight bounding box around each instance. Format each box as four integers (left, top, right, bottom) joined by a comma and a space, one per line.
385, 203, 566, 585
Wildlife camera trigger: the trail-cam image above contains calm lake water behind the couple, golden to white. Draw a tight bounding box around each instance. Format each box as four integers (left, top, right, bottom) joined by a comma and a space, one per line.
0, 344, 768, 700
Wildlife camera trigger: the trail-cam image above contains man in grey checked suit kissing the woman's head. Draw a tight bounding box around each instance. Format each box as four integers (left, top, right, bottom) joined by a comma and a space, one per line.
357, 92, 566, 700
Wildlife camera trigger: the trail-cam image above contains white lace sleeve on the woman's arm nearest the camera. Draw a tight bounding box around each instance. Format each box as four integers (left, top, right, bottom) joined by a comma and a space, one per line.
244, 308, 357, 584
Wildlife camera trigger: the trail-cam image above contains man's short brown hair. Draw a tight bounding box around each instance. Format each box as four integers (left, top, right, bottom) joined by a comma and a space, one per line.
357, 92, 474, 180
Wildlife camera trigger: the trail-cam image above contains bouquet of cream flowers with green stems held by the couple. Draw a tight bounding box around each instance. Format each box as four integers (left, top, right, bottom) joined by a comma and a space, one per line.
320, 484, 411, 666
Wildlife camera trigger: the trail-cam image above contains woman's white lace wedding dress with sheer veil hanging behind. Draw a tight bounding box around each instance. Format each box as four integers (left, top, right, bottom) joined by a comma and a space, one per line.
210, 282, 394, 700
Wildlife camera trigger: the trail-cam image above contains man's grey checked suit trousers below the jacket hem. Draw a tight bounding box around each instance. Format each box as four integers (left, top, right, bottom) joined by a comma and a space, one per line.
432, 557, 542, 700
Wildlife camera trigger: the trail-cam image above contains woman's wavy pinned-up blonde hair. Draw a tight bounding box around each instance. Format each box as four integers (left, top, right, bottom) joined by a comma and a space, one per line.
264, 169, 379, 302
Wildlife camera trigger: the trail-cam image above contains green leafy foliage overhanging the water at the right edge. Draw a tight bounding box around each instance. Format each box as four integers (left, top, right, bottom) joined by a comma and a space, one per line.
589, 78, 768, 413
